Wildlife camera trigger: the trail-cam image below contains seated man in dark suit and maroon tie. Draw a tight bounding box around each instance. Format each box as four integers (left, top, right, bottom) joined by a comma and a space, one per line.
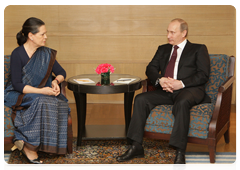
117, 18, 210, 170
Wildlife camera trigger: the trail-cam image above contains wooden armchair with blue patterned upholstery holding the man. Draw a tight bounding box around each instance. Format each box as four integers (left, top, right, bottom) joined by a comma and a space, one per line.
142, 54, 235, 163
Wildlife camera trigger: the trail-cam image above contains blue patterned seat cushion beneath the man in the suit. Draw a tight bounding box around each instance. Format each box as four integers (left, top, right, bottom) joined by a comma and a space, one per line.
145, 103, 214, 139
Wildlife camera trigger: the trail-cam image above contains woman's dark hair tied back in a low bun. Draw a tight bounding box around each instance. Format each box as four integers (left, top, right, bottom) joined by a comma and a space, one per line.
17, 17, 45, 46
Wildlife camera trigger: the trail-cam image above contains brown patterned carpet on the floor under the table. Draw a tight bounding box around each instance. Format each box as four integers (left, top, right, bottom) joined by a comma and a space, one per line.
8, 138, 175, 166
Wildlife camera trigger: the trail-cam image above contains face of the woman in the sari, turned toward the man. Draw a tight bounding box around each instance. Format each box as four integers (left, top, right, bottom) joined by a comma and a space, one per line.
29, 25, 47, 47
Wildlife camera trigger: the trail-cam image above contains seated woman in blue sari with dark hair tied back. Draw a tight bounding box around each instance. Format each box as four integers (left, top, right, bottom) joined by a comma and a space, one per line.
4, 17, 69, 164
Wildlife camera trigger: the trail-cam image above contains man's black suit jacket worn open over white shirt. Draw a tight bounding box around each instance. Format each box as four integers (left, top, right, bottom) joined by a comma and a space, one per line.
146, 41, 211, 103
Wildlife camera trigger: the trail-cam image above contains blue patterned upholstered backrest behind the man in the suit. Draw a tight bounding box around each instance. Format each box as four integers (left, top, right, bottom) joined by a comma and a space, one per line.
206, 54, 229, 104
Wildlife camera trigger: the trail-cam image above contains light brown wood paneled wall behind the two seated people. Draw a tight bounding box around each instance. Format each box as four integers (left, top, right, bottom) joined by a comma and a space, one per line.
4, 5, 238, 103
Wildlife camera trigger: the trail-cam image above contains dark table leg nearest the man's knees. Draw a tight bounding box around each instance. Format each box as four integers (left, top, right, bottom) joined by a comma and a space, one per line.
124, 92, 134, 134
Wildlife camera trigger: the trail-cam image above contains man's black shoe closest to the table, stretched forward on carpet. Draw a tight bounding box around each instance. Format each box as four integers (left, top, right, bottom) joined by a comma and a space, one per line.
116, 145, 144, 162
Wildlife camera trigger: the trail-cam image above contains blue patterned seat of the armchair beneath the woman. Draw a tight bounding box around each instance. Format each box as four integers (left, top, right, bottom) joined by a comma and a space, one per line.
4, 105, 14, 137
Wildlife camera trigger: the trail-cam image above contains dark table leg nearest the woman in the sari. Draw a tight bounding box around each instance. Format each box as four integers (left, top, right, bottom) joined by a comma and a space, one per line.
74, 92, 87, 146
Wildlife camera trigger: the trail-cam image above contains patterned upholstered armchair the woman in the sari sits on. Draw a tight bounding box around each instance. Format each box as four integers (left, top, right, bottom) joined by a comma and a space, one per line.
4, 55, 73, 154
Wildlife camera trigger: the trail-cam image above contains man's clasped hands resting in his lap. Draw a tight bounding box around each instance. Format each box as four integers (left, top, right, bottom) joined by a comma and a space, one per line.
159, 77, 183, 93
